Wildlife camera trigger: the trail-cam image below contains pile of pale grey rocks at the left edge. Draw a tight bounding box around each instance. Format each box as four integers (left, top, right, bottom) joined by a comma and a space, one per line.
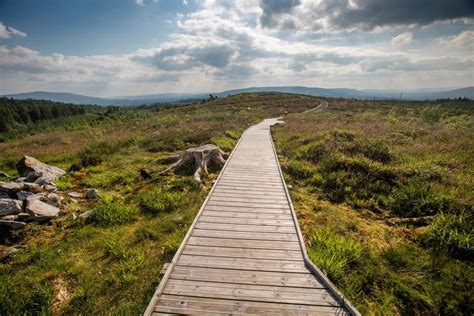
0, 156, 98, 231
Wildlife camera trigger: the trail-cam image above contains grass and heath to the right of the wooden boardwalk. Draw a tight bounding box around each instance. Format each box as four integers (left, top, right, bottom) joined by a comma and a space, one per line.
273, 99, 474, 315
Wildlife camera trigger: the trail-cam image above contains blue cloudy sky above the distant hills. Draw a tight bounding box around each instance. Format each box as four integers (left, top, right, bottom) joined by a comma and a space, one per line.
0, 0, 474, 97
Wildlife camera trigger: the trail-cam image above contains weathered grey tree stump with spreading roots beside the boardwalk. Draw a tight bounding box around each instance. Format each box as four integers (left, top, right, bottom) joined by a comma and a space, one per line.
160, 144, 228, 182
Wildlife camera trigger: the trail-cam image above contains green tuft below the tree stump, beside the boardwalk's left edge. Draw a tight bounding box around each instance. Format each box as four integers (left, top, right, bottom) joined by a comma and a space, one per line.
140, 189, 181, 214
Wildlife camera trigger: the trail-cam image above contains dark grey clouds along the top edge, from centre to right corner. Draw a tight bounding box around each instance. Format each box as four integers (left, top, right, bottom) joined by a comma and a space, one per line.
260, 0, 474, 31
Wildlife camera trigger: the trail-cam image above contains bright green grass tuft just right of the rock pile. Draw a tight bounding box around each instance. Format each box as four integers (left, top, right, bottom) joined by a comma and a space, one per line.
92, 198, 137, 226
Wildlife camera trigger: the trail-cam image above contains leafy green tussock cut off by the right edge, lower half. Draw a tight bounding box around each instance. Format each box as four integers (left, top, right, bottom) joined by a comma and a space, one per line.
426, 212, 474, 260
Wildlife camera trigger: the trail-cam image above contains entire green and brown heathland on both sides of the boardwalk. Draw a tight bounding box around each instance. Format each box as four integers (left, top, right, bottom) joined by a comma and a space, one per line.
0, 93, 474, 315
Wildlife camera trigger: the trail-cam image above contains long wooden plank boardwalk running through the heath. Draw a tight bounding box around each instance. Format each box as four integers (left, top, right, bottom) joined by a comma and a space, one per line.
145, 119, 358, 315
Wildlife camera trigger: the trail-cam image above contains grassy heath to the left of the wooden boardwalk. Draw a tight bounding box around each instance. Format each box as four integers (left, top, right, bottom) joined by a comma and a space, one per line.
0, 93, 319, 315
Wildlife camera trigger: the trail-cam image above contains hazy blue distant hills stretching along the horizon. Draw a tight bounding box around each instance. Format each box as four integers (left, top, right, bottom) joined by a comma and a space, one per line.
5, 86, 474, 106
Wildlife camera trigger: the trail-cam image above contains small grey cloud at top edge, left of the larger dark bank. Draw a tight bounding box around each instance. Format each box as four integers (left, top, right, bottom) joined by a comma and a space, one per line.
260, 0, 301, 28
